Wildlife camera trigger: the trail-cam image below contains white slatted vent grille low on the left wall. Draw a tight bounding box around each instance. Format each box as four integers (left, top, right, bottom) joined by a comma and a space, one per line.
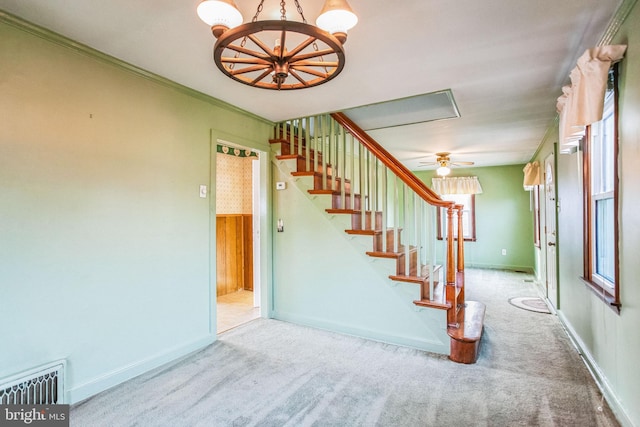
0, 360, 65, 405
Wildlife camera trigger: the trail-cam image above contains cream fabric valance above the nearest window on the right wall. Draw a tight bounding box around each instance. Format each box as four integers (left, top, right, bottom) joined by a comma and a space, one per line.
556, 45, 627, 147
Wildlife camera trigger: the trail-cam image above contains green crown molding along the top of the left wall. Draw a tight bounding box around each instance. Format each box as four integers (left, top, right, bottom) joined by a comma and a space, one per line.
0, 9, 275, 126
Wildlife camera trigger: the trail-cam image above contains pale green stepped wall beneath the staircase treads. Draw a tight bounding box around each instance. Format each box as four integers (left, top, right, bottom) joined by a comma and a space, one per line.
272, 160, 449, 354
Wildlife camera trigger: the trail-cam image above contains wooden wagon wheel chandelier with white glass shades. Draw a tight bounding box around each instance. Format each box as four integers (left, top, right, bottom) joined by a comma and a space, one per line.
197, 0, 358, 90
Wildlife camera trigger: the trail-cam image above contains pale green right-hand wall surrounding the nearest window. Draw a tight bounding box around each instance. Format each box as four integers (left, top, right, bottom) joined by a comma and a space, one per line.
536, 2, 640, 426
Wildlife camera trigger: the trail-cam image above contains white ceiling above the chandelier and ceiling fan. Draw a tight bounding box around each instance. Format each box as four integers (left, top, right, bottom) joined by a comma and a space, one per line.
0, 0, 621, 169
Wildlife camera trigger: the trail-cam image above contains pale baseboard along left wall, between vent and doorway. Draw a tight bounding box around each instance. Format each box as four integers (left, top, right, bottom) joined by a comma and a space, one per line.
65, 335, 216, 405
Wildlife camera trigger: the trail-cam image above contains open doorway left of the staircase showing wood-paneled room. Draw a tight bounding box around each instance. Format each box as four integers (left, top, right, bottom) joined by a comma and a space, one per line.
216, 141, 261, 333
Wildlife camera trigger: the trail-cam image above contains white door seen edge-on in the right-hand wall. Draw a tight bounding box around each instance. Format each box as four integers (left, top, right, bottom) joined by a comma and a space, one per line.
544, 154, 558, 308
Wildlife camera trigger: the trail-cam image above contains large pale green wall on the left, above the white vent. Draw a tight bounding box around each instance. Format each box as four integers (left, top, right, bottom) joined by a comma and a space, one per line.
0, 13, 272, 402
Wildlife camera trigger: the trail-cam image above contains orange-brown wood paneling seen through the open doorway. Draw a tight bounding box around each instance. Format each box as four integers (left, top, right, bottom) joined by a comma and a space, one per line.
216, 215, 253, 296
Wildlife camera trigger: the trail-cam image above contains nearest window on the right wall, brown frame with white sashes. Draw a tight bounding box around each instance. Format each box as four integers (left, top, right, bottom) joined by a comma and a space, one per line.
583, 66, 620, 310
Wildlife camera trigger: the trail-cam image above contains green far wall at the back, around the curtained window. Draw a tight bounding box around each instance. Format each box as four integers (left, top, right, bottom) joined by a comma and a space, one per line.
414, 165, 534, 271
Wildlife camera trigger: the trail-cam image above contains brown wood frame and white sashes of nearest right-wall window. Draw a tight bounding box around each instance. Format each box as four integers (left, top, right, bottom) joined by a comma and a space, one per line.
581, 64, 621, 313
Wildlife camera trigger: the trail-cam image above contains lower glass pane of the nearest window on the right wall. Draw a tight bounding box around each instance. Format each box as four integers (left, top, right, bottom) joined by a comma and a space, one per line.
595, 198, 615, 283
